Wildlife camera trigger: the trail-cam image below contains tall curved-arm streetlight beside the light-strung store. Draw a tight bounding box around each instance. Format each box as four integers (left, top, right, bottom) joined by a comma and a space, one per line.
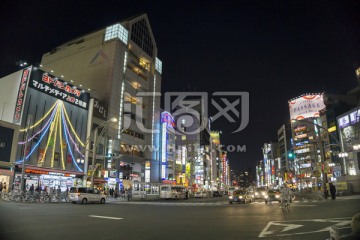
85, 118, 117, 187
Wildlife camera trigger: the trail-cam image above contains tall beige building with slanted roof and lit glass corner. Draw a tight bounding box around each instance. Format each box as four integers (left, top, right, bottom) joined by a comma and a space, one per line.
41, 14, 162, 187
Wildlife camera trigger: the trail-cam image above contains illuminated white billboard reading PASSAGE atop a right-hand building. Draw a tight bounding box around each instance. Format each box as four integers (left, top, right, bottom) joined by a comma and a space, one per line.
289, 93, 326, 120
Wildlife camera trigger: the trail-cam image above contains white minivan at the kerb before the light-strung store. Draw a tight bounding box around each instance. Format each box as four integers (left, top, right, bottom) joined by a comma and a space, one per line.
69, 187, 106, 203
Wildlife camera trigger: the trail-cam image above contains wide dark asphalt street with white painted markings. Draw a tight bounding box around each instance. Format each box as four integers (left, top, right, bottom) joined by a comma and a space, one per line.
0, 195, 360, 240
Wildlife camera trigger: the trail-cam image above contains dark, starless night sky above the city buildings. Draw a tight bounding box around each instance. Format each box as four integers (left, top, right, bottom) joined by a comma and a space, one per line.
0, 0, 360, 170
